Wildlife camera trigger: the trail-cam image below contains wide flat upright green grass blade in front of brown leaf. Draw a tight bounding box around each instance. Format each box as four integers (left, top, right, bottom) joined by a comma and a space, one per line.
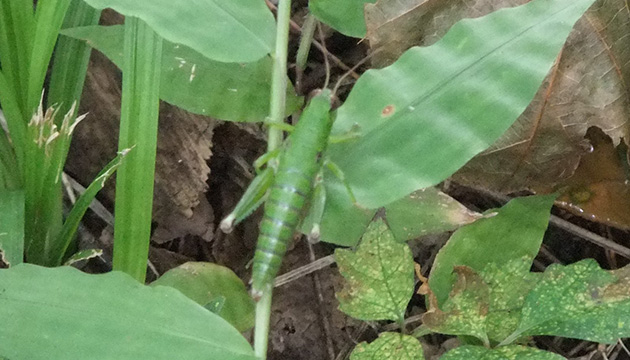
113, 17, 162, 283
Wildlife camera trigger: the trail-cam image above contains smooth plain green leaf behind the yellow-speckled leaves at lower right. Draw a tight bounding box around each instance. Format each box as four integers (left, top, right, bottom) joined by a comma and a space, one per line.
429, 195, 554, 304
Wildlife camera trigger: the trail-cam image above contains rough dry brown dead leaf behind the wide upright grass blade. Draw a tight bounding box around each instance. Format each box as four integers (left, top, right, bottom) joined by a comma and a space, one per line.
66, 12, 216, 239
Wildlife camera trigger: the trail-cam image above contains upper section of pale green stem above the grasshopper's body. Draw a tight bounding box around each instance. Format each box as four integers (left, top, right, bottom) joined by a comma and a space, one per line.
267, 0, 291, 151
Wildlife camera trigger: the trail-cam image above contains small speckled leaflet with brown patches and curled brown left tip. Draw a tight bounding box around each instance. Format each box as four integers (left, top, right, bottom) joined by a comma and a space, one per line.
422, 266, 490, 345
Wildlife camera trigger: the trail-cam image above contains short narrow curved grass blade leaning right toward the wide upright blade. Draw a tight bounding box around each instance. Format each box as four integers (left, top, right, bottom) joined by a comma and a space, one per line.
55, 150, 129, 263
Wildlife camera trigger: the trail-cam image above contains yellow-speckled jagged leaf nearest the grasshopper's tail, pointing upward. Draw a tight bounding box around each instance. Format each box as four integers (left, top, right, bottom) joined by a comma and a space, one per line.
335, 220, 414, 323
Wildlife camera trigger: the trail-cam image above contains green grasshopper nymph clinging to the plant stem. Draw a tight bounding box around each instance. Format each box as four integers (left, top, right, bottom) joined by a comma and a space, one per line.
221, 89, 348, 299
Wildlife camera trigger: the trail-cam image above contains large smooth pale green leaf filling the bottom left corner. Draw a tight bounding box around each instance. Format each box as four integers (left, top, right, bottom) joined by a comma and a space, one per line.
0, 264, 256, 360
